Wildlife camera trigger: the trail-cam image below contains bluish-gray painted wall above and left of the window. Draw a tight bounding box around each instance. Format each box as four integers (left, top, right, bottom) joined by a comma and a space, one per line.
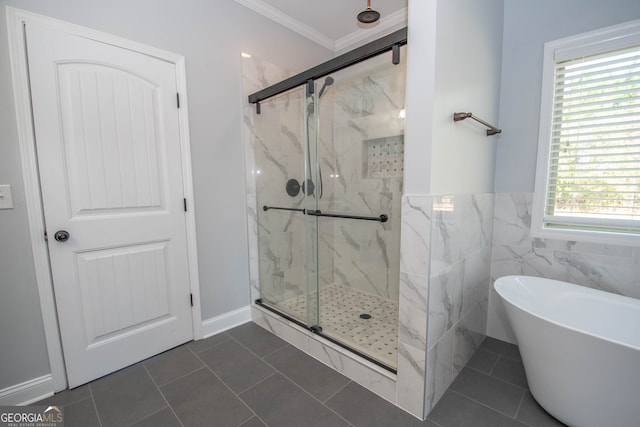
495, 0, 640, 193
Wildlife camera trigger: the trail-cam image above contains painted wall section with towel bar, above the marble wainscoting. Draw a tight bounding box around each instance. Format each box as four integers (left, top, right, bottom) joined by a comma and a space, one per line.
404, 0, 503, 195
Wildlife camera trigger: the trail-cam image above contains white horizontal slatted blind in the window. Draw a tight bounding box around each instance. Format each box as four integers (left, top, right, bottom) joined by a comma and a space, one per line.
543, 45, 640, 233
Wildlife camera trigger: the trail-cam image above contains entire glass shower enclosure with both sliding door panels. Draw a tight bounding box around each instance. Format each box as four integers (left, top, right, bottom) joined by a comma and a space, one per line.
250, 29, 406, 371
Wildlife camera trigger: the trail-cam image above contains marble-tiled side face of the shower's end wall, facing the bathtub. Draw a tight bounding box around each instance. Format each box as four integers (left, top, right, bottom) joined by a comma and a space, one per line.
426, 194, 494, 411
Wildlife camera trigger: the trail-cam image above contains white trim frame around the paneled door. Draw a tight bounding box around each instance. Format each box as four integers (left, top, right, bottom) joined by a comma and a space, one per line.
6, 6, 202, 391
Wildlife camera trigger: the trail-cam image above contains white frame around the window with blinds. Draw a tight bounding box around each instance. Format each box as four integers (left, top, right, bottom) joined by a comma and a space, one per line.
531, 20, 640, 246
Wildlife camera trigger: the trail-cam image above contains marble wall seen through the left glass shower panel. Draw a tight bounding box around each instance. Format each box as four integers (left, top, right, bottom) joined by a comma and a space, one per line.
253, 90, 306, 308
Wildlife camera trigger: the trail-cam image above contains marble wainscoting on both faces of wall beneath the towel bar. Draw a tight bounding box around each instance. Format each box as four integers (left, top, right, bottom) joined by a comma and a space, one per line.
397, 194, 494, 416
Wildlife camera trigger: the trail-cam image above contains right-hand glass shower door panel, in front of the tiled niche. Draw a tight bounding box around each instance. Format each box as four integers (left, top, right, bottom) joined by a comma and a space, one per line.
305, 49, 406, 368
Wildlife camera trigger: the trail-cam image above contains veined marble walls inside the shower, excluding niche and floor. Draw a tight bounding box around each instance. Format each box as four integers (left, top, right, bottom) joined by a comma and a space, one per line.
243, 54, 404, 308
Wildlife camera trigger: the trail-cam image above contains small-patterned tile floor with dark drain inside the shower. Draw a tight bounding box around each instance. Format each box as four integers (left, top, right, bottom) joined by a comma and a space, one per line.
277, 283, 398, 369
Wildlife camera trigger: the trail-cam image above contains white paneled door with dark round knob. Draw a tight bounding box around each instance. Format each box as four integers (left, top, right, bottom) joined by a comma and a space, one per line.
26, 24, 193, 387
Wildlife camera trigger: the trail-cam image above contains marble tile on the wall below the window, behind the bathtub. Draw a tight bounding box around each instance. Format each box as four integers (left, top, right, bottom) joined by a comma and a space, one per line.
489, 193, 640, 342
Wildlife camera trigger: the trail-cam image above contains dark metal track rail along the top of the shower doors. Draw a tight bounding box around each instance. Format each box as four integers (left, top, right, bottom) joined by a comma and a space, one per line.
249, 27, 407, 106
